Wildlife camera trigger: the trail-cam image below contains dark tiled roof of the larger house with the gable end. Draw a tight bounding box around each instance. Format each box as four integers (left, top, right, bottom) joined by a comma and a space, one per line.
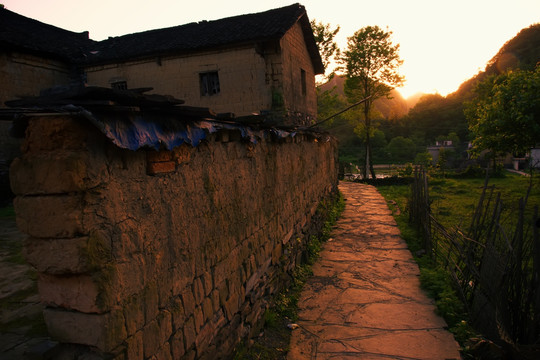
88, 4, 322, 70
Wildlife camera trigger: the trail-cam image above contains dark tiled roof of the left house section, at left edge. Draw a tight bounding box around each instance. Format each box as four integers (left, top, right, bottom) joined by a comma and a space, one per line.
0, 8, 95, 61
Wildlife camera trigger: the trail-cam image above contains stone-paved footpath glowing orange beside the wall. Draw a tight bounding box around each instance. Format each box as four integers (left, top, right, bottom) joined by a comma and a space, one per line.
288, 182, 460, 360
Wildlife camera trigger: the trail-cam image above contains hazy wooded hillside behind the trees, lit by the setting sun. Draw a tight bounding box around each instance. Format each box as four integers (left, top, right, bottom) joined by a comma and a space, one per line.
321, 24, 540, 164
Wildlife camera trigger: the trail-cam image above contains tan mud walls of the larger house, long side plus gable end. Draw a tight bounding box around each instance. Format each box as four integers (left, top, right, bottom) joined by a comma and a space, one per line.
85, 23, 317, 125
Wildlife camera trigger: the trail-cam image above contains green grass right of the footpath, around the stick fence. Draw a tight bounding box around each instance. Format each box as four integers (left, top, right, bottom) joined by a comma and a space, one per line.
377, 173, 540, 348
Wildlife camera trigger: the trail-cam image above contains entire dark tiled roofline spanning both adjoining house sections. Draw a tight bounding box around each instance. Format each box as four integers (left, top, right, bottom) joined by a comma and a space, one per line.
0, 4, 324, 73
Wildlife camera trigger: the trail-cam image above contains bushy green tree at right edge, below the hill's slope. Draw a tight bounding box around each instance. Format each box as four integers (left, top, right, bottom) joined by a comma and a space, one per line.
465, 66, 540, 155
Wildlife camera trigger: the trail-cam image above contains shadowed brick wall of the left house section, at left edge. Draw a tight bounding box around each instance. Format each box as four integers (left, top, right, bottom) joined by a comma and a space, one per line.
0, 52, 70, 108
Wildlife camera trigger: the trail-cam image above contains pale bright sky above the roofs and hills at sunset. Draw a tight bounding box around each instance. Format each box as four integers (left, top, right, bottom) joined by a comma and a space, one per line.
0, 0, 540, 97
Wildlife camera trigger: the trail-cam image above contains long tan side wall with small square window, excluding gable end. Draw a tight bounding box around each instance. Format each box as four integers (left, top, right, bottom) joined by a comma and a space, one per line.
86, 47, 271, 116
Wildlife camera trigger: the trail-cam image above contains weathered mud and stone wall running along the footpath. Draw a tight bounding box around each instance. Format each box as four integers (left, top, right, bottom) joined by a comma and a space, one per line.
11, 115, 337, 360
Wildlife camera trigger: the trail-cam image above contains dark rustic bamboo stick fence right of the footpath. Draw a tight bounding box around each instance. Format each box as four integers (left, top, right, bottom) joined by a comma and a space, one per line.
409, 169, 540, 347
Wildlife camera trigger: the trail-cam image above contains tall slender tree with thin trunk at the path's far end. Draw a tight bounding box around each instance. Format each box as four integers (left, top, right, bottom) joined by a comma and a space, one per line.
340, 26, 404, 179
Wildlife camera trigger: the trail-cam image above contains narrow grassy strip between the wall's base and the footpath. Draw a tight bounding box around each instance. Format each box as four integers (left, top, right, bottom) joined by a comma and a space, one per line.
234, 195, 345, 360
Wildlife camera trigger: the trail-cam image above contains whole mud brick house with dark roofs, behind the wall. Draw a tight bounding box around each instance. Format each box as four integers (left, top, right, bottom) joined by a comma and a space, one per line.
0, 4, 324, 125
